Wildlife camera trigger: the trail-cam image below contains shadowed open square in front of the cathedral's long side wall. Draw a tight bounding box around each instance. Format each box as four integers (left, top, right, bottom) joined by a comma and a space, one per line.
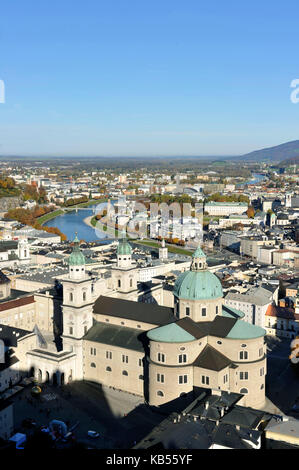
12, 382, 163, 449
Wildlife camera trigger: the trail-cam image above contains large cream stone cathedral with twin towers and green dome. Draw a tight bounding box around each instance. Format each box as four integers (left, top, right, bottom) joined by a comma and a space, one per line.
0, 236, 266, 408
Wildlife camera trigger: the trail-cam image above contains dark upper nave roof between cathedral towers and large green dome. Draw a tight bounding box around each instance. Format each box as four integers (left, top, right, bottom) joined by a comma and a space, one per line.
93, 295, 176, 325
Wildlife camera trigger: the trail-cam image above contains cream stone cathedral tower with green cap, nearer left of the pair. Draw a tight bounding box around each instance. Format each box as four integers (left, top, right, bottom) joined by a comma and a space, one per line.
61, 234, 93, 380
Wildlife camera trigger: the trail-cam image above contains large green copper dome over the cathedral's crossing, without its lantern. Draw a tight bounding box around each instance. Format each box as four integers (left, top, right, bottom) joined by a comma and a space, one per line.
173, 270, 223, 300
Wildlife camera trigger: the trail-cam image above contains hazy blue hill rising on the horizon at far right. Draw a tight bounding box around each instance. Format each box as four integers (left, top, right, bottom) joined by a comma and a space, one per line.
239, 140, 299, 162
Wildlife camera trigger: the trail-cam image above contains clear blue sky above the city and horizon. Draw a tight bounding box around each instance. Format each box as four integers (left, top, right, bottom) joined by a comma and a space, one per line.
0, 0, 299, 156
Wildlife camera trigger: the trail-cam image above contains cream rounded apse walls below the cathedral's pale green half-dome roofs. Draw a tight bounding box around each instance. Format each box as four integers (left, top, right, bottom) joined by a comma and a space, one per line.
149, 336, 267, 407
